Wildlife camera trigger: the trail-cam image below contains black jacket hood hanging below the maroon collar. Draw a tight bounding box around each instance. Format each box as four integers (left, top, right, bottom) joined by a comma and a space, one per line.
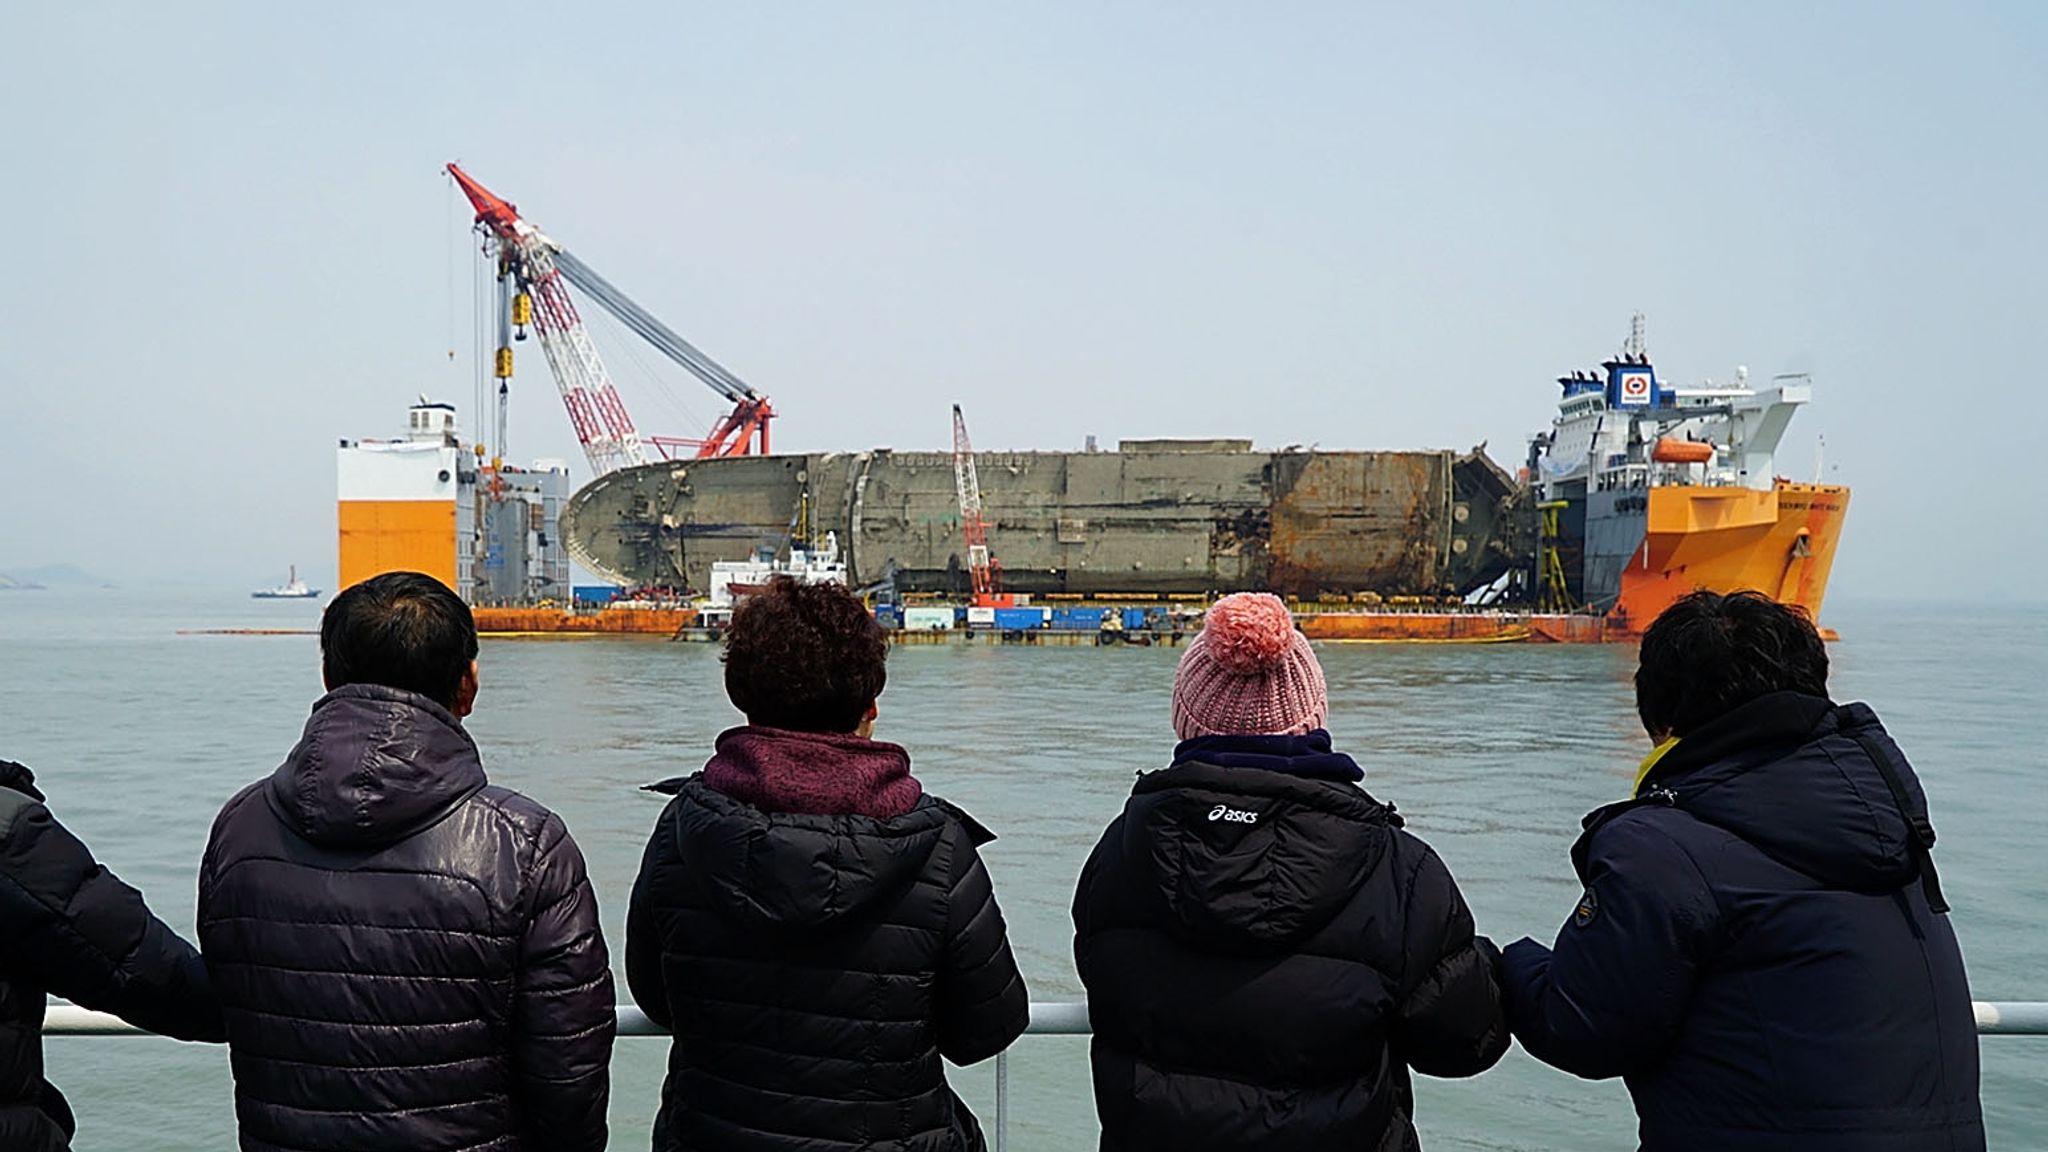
671, 773, 973, 931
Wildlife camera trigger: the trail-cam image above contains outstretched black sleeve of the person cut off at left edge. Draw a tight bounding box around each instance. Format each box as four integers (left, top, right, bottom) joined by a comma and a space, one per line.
0, 778, 227, 1041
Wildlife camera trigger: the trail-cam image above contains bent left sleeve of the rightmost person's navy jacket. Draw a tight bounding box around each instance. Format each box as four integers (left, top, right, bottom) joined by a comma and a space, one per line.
1501, 818, 1718, 1080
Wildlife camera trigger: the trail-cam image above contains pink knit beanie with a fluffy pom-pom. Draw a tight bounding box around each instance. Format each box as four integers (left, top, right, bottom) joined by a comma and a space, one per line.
1174, 592, 1329, 740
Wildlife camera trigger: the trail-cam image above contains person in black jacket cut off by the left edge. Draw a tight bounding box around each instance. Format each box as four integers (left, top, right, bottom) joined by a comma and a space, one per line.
0, 760, 227, 1152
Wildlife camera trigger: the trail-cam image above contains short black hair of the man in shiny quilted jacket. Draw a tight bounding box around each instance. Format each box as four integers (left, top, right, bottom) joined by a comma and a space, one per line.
319, 572, 477, 707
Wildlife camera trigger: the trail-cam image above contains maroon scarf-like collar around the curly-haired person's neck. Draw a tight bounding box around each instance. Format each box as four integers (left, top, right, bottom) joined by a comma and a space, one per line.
705, 724, 924, 820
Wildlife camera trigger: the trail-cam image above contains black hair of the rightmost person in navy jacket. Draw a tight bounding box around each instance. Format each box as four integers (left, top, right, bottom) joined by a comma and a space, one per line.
1636, 590, 1827, 736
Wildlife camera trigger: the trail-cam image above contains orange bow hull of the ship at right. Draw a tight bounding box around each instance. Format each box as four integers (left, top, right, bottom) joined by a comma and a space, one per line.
1608, 482, 1849, 635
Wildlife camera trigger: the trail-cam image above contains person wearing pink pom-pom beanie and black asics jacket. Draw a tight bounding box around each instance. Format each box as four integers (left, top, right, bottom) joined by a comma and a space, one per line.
1073, 592, 1507, 1152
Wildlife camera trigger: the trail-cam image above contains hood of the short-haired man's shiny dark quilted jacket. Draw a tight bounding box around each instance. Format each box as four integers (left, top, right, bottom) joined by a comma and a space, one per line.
268, 685, 487, 849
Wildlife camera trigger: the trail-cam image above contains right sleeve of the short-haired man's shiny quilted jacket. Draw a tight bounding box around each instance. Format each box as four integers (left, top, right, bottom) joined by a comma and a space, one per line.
512, 816, 616, 1152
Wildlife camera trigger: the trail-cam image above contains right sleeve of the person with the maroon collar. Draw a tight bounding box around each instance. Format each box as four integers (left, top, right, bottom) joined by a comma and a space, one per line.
936, 822, 1030, 1064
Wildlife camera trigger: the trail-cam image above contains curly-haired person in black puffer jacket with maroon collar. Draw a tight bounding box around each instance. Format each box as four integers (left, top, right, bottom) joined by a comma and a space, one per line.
627, 576, 1030, 1152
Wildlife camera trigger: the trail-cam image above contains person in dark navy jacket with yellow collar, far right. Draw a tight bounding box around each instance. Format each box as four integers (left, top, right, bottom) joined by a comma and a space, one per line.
1501, 592, 1985, 1152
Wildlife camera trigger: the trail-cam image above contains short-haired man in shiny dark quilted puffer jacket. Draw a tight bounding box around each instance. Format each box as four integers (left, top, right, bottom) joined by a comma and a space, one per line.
199, 572, 616, 1152
